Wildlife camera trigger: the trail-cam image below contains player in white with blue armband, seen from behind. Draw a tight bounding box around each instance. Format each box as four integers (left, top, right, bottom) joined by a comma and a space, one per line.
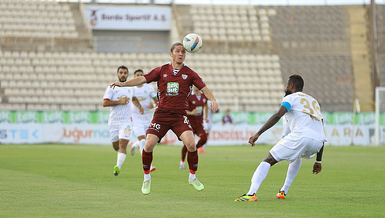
235, 74, 326, 201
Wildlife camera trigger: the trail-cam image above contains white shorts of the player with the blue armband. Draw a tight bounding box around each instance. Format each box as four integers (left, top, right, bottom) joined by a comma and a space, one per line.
270, 138, 323, 163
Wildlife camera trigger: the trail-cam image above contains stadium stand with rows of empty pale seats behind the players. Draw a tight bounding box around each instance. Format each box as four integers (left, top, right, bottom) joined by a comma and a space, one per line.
0, 0, 378, 111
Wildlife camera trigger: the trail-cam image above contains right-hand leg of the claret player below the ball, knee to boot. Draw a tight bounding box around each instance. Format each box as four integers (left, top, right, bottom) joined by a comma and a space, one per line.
179, 130, 204, 191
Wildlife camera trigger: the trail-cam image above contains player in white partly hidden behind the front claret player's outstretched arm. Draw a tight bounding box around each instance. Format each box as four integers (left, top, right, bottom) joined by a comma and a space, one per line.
130, 69, 158, 172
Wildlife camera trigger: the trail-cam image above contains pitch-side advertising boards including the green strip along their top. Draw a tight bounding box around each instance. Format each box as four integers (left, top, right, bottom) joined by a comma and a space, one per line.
0, 111, 385, 146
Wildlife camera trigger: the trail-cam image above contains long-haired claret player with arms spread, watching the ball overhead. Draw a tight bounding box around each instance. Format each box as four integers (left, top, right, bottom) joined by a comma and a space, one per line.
110, 42, 218, 194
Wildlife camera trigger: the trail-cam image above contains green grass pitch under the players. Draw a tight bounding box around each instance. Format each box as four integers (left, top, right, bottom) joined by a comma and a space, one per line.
0, 145, 385, 217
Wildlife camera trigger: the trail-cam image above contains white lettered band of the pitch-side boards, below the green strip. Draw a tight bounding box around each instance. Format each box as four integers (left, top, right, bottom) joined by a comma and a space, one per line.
0, 123, 376, 146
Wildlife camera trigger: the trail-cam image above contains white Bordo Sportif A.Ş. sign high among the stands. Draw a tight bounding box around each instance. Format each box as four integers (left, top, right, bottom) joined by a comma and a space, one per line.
84, 6, 172, 31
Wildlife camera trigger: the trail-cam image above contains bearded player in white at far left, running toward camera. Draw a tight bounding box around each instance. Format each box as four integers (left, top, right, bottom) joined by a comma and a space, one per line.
103, 66, 144, 176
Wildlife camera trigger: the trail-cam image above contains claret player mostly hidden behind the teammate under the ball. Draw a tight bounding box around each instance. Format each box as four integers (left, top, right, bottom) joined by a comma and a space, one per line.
179, 86, 208, 170
